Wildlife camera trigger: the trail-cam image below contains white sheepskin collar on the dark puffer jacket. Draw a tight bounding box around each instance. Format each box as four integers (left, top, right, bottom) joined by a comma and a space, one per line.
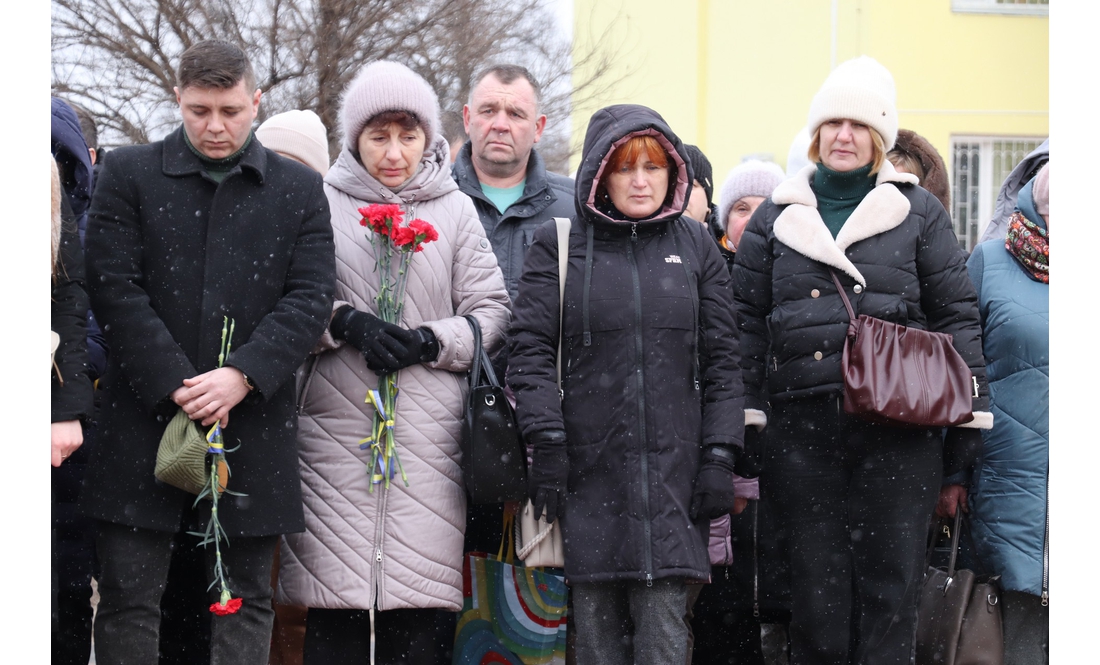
771, 160, 917, 287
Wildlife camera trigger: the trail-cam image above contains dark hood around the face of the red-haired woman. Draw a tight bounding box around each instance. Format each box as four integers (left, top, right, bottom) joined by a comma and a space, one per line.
573, 104, 693, 224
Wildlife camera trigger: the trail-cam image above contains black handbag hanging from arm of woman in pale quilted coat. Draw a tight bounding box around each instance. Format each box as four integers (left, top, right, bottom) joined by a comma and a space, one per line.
461, 314, 527, 505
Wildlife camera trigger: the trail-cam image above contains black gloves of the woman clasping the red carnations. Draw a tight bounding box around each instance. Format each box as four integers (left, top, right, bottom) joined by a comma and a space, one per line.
329, 304, 439, 374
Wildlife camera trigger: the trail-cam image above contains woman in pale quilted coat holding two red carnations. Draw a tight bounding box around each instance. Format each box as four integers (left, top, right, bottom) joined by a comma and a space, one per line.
276, 62, 509, 665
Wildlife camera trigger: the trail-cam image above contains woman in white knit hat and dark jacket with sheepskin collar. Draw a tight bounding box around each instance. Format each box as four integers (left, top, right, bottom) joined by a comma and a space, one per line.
734, 56, 992, 664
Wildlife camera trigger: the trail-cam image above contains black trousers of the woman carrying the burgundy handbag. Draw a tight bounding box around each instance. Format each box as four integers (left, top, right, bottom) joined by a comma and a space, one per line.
761, 398, 943, 665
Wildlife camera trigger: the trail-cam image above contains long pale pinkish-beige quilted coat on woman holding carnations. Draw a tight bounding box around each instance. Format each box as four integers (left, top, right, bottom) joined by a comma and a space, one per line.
276, 138, 509, 611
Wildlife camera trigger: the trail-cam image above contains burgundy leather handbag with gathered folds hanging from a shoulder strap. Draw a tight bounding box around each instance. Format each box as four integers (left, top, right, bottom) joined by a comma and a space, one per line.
829, 270, 978, 428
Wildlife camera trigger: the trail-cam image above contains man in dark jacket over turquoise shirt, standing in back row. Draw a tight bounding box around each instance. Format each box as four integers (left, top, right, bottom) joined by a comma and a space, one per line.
452, 65, 574, 302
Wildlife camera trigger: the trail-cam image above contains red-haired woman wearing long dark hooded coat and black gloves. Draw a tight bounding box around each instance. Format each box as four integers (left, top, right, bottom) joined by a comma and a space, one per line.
508, 104, 745, 664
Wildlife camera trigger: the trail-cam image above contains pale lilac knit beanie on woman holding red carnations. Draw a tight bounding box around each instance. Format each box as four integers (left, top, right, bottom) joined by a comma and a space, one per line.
340, 60, 440, 153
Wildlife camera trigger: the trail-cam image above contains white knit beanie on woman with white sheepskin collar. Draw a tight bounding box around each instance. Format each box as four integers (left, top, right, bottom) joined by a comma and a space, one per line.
806, 55, 898, 151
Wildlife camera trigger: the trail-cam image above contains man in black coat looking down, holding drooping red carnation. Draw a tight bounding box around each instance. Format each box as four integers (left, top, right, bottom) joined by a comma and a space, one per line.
83, 42, 334, 664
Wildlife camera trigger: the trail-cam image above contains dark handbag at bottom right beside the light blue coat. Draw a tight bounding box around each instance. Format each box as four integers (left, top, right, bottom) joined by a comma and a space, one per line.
916, 509, 1004, 665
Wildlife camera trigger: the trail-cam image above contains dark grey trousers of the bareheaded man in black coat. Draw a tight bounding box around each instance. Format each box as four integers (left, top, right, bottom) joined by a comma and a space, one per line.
95, 521, 278, 665
